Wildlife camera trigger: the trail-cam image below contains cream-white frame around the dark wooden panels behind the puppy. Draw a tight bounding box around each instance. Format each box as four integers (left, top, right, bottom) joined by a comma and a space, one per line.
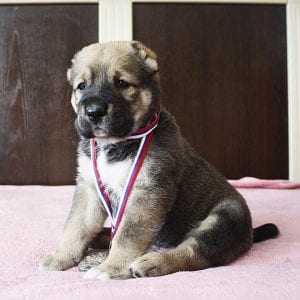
0, 0, 300, 180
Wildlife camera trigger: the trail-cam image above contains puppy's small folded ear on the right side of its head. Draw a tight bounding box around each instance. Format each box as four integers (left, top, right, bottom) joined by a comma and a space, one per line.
131, 41, 159, 75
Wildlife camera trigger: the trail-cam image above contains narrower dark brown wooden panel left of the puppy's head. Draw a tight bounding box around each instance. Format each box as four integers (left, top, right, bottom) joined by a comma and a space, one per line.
0, 5, 98, 184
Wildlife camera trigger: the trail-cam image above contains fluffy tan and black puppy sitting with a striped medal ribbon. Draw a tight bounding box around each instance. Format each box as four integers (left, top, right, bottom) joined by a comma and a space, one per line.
40, 41, 278, 279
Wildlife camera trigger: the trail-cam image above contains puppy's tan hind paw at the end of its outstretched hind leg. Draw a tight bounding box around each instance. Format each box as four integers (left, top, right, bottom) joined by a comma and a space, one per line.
130, 252, 168, 278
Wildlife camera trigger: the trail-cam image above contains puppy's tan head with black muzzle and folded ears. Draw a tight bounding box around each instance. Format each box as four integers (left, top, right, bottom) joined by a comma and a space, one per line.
67, 41, 159, 142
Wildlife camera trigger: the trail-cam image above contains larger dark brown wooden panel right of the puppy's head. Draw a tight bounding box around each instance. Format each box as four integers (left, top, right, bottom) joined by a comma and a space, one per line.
133, 4, 288, 178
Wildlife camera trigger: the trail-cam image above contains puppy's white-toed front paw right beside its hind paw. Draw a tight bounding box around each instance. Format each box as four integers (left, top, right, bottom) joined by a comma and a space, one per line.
83, 263, 131, 280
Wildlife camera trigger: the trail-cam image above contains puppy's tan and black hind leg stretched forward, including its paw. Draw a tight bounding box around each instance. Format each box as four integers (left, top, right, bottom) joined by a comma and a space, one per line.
130, 200, 252, 277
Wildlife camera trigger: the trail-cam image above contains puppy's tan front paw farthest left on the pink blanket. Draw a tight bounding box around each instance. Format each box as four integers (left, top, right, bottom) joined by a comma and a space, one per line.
39, 254, 77, 271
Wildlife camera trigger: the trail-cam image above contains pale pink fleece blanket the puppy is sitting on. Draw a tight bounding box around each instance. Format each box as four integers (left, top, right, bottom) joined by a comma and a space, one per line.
0, 180, 300, 300
